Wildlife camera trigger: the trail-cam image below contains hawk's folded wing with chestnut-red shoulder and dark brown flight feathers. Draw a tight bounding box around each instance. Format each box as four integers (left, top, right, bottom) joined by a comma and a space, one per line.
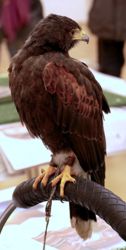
43, 58, 109, 184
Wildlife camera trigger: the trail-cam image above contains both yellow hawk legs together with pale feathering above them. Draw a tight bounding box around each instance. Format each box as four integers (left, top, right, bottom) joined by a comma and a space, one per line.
33, 151, 77, 197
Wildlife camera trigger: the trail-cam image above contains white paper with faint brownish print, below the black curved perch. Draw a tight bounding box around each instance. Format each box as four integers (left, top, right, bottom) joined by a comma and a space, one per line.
0, 201, 126, 250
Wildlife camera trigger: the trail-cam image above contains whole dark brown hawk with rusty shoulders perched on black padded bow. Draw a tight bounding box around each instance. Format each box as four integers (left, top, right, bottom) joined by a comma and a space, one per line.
9, 14, 110, 239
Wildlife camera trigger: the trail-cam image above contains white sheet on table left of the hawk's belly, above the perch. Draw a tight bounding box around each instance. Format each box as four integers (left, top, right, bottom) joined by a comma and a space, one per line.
0, 123, 51, 173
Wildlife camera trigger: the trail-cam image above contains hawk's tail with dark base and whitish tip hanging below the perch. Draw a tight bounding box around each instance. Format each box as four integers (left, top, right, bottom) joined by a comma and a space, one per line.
70, 203, 96, 240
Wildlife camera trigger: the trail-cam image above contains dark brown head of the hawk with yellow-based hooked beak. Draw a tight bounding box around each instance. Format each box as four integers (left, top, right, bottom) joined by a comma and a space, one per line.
25, 14, 89, 52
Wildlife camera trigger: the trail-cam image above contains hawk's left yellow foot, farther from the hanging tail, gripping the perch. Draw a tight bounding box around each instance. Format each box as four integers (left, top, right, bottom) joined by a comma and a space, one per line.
33, 166, 56, 189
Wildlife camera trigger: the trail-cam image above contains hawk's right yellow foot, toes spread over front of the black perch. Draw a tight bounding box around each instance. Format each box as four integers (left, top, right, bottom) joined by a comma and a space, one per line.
51, 165, 76, 197
